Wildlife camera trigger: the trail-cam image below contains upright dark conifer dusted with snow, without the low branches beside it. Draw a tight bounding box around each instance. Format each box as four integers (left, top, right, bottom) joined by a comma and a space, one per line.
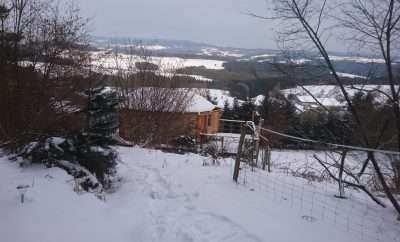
74, 87, 121, 188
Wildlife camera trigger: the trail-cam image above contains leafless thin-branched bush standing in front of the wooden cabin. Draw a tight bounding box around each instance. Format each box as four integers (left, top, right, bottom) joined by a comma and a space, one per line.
98, 42, 195, 145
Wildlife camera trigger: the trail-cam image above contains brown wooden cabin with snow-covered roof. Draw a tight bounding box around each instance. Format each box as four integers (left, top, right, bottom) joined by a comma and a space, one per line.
120, 88, 221, 143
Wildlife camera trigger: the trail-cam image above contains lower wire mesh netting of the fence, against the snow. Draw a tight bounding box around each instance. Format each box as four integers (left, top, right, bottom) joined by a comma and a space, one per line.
238, 159, 400, 242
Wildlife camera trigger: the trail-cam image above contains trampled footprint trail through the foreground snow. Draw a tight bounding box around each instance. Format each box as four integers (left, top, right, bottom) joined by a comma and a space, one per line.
115, 150, 261, 242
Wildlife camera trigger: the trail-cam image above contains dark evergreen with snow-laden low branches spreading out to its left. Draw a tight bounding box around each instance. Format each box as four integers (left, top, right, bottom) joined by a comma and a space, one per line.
14, 87, 120, 192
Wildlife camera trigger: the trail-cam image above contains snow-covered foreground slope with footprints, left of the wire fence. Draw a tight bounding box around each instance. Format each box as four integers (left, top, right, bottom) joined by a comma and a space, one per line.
0, 148, 399, 242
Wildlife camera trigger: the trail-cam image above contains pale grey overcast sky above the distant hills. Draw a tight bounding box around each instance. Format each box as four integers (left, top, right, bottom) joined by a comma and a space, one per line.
77, 0, 276, 48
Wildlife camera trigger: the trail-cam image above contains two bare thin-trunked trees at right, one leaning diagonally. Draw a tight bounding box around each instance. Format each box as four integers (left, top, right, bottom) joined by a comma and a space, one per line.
254, 0, 400, 215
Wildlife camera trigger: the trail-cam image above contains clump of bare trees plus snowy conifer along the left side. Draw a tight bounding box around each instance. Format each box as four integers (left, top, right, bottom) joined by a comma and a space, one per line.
0, 0, 121, 194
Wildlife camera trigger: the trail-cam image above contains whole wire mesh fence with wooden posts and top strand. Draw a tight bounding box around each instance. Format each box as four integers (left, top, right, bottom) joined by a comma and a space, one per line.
217, 120, 400, 242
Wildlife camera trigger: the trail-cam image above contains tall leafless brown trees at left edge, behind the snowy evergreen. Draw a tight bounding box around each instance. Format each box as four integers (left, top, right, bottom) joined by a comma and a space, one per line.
0, 0, 88, 150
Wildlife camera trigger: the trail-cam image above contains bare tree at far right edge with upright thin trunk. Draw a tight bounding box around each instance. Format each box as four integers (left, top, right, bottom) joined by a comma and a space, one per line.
337, 0, 400, 150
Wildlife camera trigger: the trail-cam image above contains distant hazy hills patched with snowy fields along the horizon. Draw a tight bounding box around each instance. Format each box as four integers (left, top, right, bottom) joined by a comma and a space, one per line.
91, 37, 400, 86
